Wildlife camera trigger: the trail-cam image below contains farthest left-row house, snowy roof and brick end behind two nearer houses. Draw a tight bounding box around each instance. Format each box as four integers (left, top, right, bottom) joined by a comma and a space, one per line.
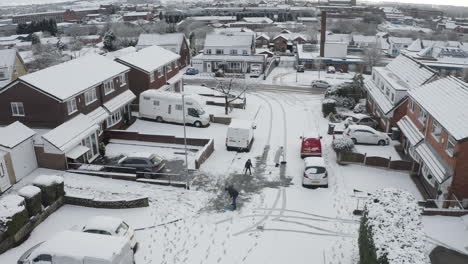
136, 33, 191, 69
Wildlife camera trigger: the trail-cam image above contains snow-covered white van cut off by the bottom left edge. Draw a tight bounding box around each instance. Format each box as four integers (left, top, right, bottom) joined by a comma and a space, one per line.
18, 231, 134, 264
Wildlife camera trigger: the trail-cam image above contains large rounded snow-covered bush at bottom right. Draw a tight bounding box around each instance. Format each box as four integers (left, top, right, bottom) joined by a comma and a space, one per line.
359, 188, 430, 264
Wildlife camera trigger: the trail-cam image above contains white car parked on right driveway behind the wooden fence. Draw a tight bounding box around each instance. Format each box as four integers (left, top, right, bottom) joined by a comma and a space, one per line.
343, 125, 390, 146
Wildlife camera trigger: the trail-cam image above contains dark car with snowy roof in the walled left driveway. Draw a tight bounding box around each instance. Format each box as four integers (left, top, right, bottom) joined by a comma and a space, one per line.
118, 153, 166, 178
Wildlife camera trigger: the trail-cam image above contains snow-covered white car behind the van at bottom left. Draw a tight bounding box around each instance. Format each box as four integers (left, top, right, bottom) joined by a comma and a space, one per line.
82, 216, 137, 251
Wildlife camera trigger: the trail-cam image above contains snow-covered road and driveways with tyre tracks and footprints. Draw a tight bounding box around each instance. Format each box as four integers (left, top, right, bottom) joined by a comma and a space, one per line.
0, 73, 467, 264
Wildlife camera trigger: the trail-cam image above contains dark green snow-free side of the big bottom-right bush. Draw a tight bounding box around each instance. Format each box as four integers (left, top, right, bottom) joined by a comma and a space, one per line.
358, 213, 388, 264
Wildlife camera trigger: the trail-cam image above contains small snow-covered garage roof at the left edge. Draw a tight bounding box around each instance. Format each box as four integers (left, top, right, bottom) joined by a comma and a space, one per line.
0, 121, 36, 149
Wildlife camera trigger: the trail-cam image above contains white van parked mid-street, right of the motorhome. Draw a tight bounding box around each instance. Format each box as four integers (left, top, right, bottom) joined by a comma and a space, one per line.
226, 119, 255, 151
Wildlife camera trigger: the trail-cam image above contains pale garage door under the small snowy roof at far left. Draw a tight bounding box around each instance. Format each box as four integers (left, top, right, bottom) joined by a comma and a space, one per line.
10, 138, 37, 181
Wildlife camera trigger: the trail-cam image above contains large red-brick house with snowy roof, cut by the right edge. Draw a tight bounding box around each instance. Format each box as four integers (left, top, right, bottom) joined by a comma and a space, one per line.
398, 77, 468, 207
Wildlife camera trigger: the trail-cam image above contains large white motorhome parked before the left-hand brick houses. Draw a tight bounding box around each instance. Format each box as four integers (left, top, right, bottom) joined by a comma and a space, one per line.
140, 90, 210, 127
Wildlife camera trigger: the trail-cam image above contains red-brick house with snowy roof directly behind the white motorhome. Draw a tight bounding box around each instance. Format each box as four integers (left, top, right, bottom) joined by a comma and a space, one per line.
115, 46, 182, 101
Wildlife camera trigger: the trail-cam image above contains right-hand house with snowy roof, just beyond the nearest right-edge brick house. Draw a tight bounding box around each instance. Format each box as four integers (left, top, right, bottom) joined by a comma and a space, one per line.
364, 54, 438, 132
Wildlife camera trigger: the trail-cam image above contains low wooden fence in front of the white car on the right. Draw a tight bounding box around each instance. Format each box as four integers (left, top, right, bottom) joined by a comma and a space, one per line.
337, 151, 419, 172
